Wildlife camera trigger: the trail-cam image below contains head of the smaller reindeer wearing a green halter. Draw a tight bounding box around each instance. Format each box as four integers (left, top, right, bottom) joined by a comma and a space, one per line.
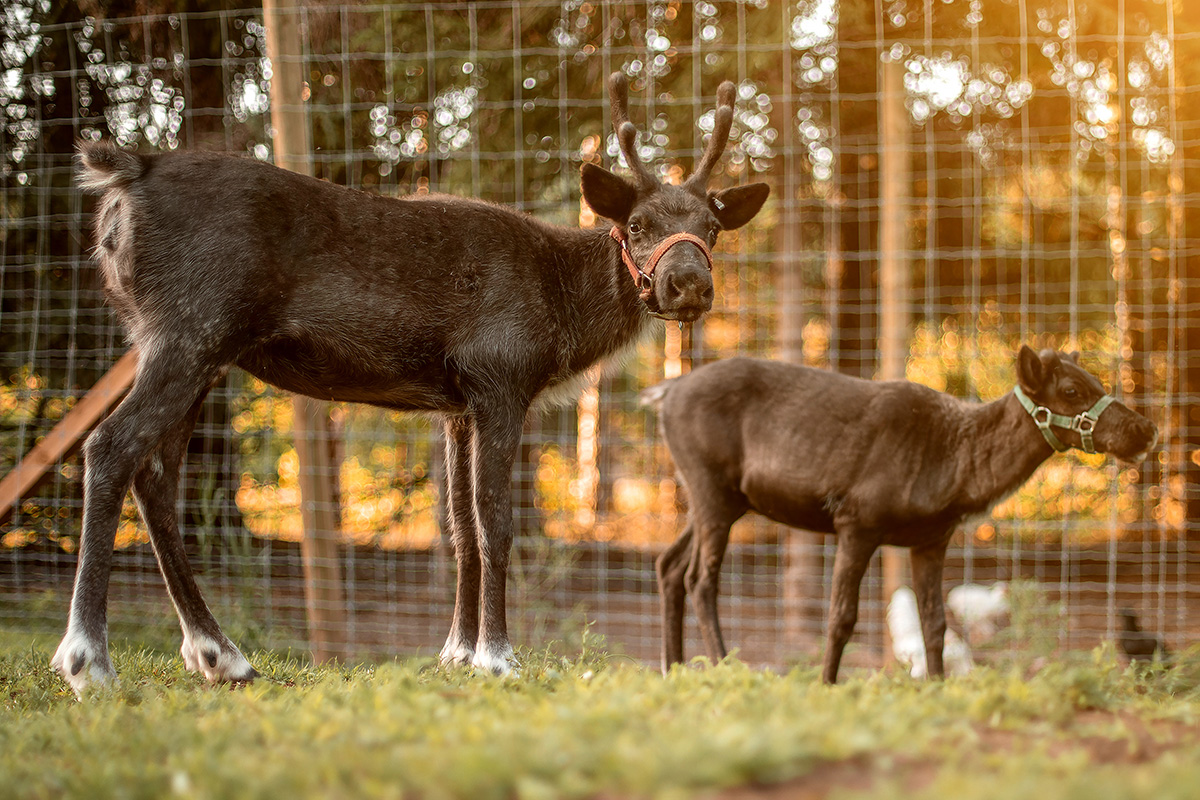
1016, 345, 1158, 463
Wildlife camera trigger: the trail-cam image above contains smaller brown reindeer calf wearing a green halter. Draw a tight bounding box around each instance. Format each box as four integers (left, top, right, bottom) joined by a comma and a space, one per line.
642, 347, 1158, 684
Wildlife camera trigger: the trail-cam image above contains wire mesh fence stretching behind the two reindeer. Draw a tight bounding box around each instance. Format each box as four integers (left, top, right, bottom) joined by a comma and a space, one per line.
0, 0, 1200, 664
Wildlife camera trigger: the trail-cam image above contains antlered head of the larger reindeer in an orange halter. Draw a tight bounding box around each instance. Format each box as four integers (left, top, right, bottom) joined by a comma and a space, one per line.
583, 72, 770, 323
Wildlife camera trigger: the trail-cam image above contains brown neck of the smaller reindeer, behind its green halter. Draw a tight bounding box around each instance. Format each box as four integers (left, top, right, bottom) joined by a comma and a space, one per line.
961, 392, 1054, 511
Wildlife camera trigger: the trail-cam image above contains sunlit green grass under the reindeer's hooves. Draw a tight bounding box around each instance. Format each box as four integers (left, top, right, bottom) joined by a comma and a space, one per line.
0, 632, 1200, 800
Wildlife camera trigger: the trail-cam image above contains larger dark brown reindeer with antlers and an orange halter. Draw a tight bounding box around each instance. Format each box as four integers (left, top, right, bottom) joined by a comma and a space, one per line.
53, 73, 767, 692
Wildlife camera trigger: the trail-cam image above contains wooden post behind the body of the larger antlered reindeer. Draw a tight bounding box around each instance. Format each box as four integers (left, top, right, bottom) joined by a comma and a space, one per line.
263, 0, 346, 662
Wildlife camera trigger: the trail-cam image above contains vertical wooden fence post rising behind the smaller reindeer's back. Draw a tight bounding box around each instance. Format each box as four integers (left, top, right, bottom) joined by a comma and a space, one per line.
880, 59, 912, 658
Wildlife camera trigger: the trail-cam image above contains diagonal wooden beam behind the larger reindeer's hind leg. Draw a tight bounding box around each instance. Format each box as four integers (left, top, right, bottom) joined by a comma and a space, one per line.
0, 350, 138, 524
